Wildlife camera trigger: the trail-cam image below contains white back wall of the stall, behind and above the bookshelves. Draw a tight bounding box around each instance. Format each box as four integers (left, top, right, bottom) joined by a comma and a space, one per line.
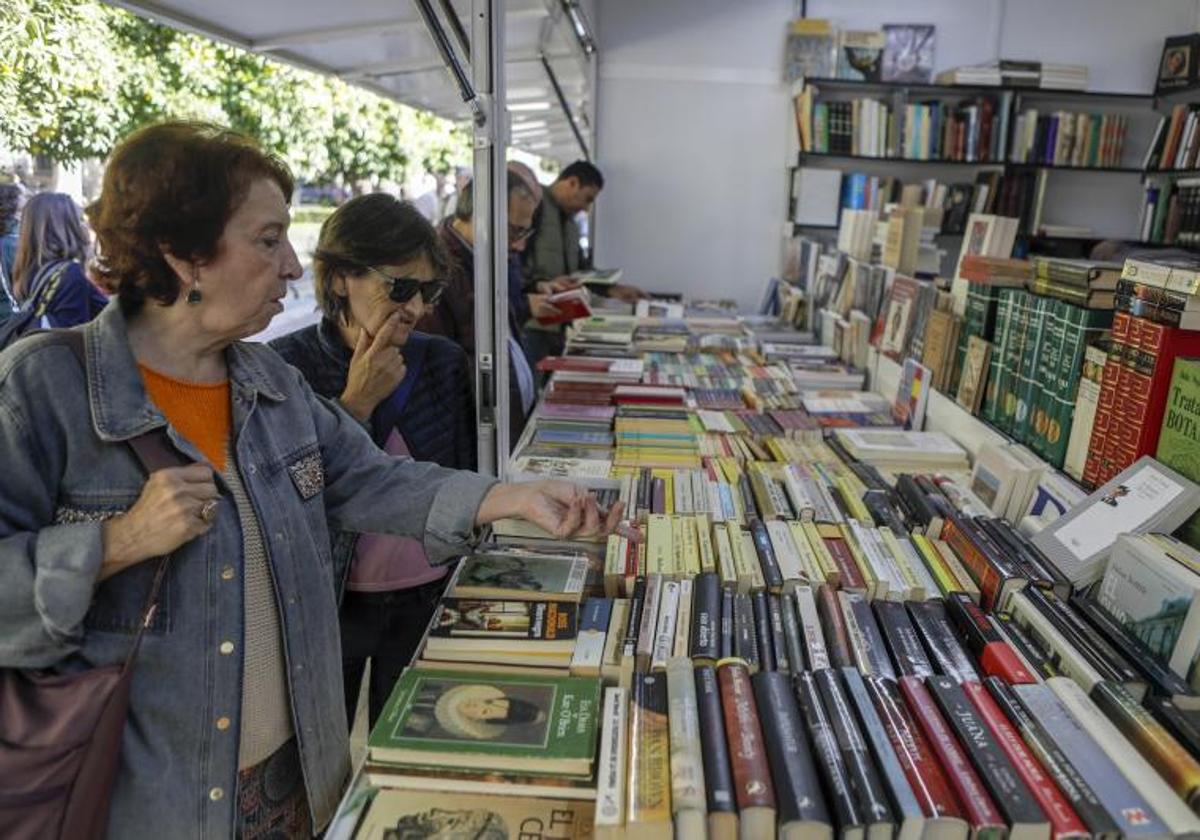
595, 0, 1200, 307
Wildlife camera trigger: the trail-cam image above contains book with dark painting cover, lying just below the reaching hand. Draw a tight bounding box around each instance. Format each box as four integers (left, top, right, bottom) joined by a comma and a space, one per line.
448, 552, 588, 601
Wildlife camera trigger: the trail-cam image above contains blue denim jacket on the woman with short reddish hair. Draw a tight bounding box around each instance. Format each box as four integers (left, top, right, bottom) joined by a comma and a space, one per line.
0, 301, 493, 838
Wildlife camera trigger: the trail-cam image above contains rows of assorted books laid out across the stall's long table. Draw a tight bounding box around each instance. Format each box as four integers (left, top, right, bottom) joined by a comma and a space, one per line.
343, 303, 1200, 839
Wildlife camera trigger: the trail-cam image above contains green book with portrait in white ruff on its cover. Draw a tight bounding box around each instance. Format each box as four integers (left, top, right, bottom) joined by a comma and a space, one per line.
367, 668, 600, 776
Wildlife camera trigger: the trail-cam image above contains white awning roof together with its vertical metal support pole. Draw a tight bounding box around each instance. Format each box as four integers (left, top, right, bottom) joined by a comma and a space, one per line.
108, 0, 596, 475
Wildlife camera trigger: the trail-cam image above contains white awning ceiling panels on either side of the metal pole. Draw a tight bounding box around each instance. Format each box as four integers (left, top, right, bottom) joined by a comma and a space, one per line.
109, 0, 592, 162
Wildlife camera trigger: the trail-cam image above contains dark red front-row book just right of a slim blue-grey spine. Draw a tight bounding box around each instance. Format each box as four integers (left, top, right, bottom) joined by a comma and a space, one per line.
864, 677, 965, 820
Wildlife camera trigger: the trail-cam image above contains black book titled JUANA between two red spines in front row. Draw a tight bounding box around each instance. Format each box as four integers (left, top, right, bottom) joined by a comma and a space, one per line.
925, 677, 1050, 840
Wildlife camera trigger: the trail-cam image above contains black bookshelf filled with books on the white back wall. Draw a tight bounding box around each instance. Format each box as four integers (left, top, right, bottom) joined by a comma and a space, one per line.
787, 77, 1200, 247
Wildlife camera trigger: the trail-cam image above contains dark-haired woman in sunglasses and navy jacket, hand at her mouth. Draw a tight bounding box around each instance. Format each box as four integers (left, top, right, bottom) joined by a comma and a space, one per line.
271, 193, 476, 726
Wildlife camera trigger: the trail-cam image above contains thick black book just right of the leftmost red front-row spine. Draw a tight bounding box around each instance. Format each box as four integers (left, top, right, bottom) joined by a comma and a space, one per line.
751, 671, 833, 840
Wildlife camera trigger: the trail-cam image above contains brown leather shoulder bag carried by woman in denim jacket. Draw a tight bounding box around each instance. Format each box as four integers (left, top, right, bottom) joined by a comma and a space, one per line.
0, 329, 188, 840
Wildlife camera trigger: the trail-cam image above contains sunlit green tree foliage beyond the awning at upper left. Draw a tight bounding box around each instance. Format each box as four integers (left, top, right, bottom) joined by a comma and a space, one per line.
0, 0, 470, 186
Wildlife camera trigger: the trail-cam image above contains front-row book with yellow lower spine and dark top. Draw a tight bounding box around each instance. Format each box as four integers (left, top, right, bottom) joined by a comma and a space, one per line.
626, 673, 671, 828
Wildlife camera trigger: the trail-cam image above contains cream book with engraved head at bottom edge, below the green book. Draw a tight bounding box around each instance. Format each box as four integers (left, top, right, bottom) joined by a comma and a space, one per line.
354, 788, 595, 840
